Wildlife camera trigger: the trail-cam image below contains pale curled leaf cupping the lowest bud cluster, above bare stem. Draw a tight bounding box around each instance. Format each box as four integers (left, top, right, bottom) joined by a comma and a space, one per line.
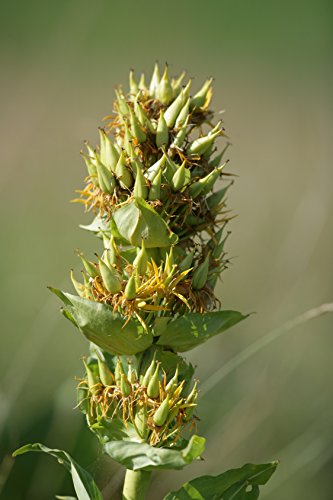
104, 436, 206, 470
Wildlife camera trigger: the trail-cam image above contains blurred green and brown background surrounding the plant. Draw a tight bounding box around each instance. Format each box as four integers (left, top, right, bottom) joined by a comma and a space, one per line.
0, 0, 333, 500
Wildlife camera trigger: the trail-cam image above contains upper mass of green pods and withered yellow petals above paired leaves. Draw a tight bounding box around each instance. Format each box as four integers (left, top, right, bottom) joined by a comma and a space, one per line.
74, 64, 230, 320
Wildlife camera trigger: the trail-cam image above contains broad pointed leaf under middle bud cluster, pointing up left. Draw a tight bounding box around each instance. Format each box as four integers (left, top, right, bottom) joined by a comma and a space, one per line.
50, 288, 153, 355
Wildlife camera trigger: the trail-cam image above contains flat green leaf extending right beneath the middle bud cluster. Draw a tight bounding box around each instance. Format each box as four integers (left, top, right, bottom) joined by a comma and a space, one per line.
157, 311, 248, 352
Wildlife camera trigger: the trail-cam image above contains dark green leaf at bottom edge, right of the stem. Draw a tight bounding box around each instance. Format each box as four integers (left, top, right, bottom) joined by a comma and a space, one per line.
164, 462, 278, 500
